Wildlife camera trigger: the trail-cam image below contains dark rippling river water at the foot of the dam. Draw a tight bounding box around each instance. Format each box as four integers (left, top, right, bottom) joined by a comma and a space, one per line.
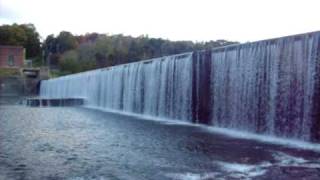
0, 106, 320, 180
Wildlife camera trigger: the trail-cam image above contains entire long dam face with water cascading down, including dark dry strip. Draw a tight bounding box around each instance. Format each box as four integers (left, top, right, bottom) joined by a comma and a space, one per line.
41, 32, 320, 141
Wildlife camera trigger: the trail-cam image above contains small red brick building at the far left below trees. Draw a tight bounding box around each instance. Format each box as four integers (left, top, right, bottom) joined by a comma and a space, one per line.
0, 45, 25, 68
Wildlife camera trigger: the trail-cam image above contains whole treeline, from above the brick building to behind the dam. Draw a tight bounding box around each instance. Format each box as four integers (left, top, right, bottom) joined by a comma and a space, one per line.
0, 24, 237, 75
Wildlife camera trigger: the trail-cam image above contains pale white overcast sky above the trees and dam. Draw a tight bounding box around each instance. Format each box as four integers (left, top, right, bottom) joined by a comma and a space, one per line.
0, 0, 320, 42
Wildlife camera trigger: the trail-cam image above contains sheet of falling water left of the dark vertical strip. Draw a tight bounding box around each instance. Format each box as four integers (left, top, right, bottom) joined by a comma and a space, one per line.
41, 53, 192, 121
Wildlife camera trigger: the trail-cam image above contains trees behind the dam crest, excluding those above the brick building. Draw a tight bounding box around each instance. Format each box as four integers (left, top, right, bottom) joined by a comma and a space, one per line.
43, 31, 236, 74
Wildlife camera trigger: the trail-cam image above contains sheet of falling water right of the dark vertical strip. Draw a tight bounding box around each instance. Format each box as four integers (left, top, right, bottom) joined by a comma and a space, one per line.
211, 33, 319, 140
